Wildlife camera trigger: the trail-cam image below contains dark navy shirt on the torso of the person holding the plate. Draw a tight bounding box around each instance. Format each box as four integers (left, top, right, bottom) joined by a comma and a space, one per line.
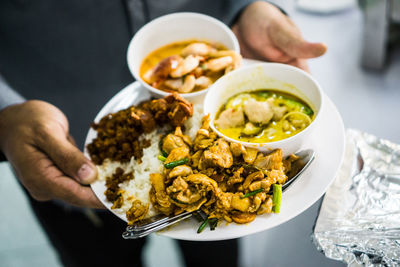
0, 0, 250, 148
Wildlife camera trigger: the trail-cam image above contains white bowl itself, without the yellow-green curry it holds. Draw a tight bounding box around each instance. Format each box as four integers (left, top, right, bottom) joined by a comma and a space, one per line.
204, 63, 323, 156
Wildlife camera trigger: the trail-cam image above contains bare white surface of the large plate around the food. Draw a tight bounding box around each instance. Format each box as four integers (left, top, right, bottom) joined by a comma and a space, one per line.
85, 61, 345, 241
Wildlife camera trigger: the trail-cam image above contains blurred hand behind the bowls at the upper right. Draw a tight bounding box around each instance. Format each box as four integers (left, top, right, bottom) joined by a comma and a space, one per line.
232, 1, 327, 71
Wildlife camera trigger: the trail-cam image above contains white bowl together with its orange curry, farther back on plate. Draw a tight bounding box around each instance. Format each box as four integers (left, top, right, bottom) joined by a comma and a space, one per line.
127, 12, 242, 102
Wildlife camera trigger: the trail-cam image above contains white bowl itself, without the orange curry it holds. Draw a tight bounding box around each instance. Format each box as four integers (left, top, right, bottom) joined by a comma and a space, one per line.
127, 12, 240, 103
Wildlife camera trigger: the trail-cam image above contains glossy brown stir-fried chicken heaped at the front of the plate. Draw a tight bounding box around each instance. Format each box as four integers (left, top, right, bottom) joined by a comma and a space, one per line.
148, 116, 294, 226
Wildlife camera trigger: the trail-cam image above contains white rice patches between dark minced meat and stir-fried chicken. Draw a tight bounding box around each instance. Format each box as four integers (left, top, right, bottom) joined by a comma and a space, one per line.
97, 105, 203, 218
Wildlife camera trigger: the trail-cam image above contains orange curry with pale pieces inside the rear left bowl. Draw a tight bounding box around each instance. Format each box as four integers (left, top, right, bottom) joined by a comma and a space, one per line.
140, 40, 242, 94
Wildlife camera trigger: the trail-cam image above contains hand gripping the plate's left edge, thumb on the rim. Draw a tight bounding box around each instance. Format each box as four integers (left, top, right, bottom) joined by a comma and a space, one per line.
0, 100, 104, 208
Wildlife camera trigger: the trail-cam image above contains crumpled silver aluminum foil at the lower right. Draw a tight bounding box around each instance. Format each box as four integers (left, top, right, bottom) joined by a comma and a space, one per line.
312, 129, 400, 266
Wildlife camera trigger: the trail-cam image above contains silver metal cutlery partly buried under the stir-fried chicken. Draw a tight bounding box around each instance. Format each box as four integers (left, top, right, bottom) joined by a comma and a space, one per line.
122, 149, 315, 239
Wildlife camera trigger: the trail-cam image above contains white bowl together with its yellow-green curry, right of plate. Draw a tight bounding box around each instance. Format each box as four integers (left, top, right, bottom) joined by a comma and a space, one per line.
204, 63, 323, 155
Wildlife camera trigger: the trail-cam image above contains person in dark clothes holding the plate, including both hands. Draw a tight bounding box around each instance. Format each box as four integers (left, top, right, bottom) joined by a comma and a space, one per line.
0, 0, 326, 266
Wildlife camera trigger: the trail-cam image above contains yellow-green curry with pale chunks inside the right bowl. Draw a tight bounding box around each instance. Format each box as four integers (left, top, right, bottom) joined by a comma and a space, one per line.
215, 89, 314, 143
